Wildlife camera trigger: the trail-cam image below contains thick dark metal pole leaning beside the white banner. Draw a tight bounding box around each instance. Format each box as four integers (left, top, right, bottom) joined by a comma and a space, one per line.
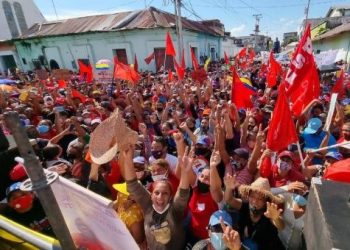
4, 111, 76, 250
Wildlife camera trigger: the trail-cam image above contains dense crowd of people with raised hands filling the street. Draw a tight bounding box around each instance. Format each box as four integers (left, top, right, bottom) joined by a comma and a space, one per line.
0, 55, 350, 250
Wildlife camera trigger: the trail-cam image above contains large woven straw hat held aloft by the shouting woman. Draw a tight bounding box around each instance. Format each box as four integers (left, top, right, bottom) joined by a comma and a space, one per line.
89, 109, 137, 165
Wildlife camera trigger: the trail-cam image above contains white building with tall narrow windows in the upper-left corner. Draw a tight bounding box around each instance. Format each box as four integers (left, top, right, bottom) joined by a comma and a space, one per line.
0, 0, 45, 72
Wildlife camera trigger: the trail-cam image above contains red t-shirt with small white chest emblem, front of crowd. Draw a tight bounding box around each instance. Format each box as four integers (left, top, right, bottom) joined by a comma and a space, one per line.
188, 188, 219, 240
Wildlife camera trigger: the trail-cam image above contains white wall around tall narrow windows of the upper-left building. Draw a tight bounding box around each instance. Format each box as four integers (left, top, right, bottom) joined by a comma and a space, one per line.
0, 0, 45, 40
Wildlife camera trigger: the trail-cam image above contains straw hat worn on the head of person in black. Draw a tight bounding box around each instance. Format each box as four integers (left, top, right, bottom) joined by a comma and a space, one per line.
239, 177, 284, 204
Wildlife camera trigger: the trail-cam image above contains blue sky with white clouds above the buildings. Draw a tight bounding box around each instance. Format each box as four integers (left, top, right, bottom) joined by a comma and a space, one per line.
34, 0, 349, 39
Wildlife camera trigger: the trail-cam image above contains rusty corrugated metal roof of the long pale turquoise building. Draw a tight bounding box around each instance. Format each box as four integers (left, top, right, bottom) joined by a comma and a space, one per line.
19, 7, 221, 39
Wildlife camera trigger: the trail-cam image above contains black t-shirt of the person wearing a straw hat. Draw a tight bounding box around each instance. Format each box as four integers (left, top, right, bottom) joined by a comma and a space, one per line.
238, 202, 285, 250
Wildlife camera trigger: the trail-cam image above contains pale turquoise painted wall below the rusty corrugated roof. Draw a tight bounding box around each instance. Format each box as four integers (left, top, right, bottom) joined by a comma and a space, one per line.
15, 29, 222, 71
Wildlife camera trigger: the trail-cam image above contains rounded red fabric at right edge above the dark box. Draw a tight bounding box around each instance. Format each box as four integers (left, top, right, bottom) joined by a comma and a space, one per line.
323, 158, 350, 183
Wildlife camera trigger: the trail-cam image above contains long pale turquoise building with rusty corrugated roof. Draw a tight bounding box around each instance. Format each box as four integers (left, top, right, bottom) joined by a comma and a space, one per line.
14, 7, 224, 71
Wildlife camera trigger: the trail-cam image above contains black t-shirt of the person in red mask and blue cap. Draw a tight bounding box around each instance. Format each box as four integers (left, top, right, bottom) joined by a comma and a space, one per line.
4, 199, 55, 237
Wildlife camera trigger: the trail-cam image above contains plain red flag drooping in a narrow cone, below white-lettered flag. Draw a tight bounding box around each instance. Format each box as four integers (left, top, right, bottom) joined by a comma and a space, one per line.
266, 84, 298, 151
